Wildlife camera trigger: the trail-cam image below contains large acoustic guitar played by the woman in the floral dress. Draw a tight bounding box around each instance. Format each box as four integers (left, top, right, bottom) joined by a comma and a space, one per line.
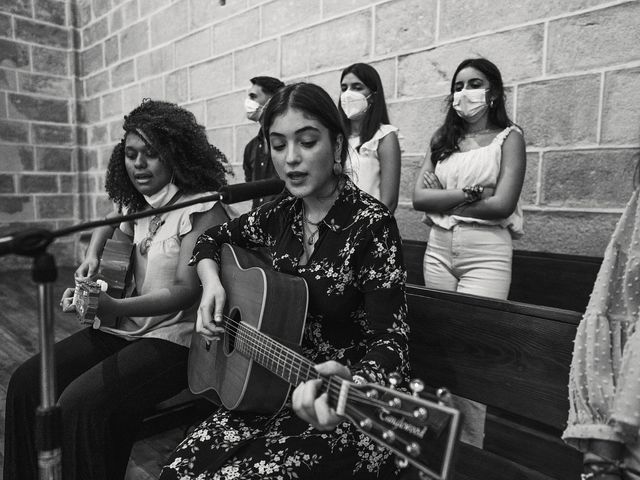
188, 244, 460, 480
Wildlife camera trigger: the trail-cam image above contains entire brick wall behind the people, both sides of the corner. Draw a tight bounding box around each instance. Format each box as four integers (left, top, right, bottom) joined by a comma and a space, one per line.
0, 0, 640, 270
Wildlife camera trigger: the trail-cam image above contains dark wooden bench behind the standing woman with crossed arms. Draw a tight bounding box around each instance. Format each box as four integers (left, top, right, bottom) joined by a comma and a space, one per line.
402, 240, 602, 312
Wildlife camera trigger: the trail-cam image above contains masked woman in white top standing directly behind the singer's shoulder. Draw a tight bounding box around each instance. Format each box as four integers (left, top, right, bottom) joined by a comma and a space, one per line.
338, 63, 400, 213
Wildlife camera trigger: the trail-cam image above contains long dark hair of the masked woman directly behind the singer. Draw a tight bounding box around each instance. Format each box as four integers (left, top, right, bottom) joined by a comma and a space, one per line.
338, 63, 390, 152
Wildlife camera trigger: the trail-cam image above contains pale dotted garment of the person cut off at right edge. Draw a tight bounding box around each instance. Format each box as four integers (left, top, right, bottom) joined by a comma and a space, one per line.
562, 189, 640, 480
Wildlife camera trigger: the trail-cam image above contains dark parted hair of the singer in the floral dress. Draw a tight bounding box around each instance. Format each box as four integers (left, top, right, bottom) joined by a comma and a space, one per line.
262, 82, 348, 166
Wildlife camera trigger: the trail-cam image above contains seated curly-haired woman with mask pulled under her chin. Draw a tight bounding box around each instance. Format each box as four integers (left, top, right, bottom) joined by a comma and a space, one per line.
4, 100, 228, 480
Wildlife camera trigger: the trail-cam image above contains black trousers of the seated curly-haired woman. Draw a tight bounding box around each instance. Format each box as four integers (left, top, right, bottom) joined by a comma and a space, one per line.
4, 328, 189, 480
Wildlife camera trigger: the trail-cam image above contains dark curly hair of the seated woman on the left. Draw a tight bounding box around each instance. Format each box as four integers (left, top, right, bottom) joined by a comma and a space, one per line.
106, 99, 231, 213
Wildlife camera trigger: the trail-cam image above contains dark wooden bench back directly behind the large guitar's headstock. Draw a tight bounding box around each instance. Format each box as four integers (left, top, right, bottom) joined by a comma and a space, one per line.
403, 285, 582, 480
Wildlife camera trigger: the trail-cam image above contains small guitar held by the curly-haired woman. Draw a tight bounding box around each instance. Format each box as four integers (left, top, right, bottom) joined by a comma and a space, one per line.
71, 239, 134, 328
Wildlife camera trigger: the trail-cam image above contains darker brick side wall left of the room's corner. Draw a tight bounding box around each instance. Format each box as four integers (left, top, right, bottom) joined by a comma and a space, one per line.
0, 0, 75, 268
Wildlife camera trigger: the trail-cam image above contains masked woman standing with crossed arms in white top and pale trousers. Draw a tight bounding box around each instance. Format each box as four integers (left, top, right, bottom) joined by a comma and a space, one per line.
413, 58, 525, 299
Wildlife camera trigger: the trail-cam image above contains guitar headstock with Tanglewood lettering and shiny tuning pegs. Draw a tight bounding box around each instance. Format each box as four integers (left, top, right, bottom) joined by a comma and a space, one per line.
337, 379, 461, 480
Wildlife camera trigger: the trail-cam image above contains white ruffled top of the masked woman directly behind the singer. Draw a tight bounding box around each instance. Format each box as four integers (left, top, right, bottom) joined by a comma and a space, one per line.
346, 125, 398, 200
